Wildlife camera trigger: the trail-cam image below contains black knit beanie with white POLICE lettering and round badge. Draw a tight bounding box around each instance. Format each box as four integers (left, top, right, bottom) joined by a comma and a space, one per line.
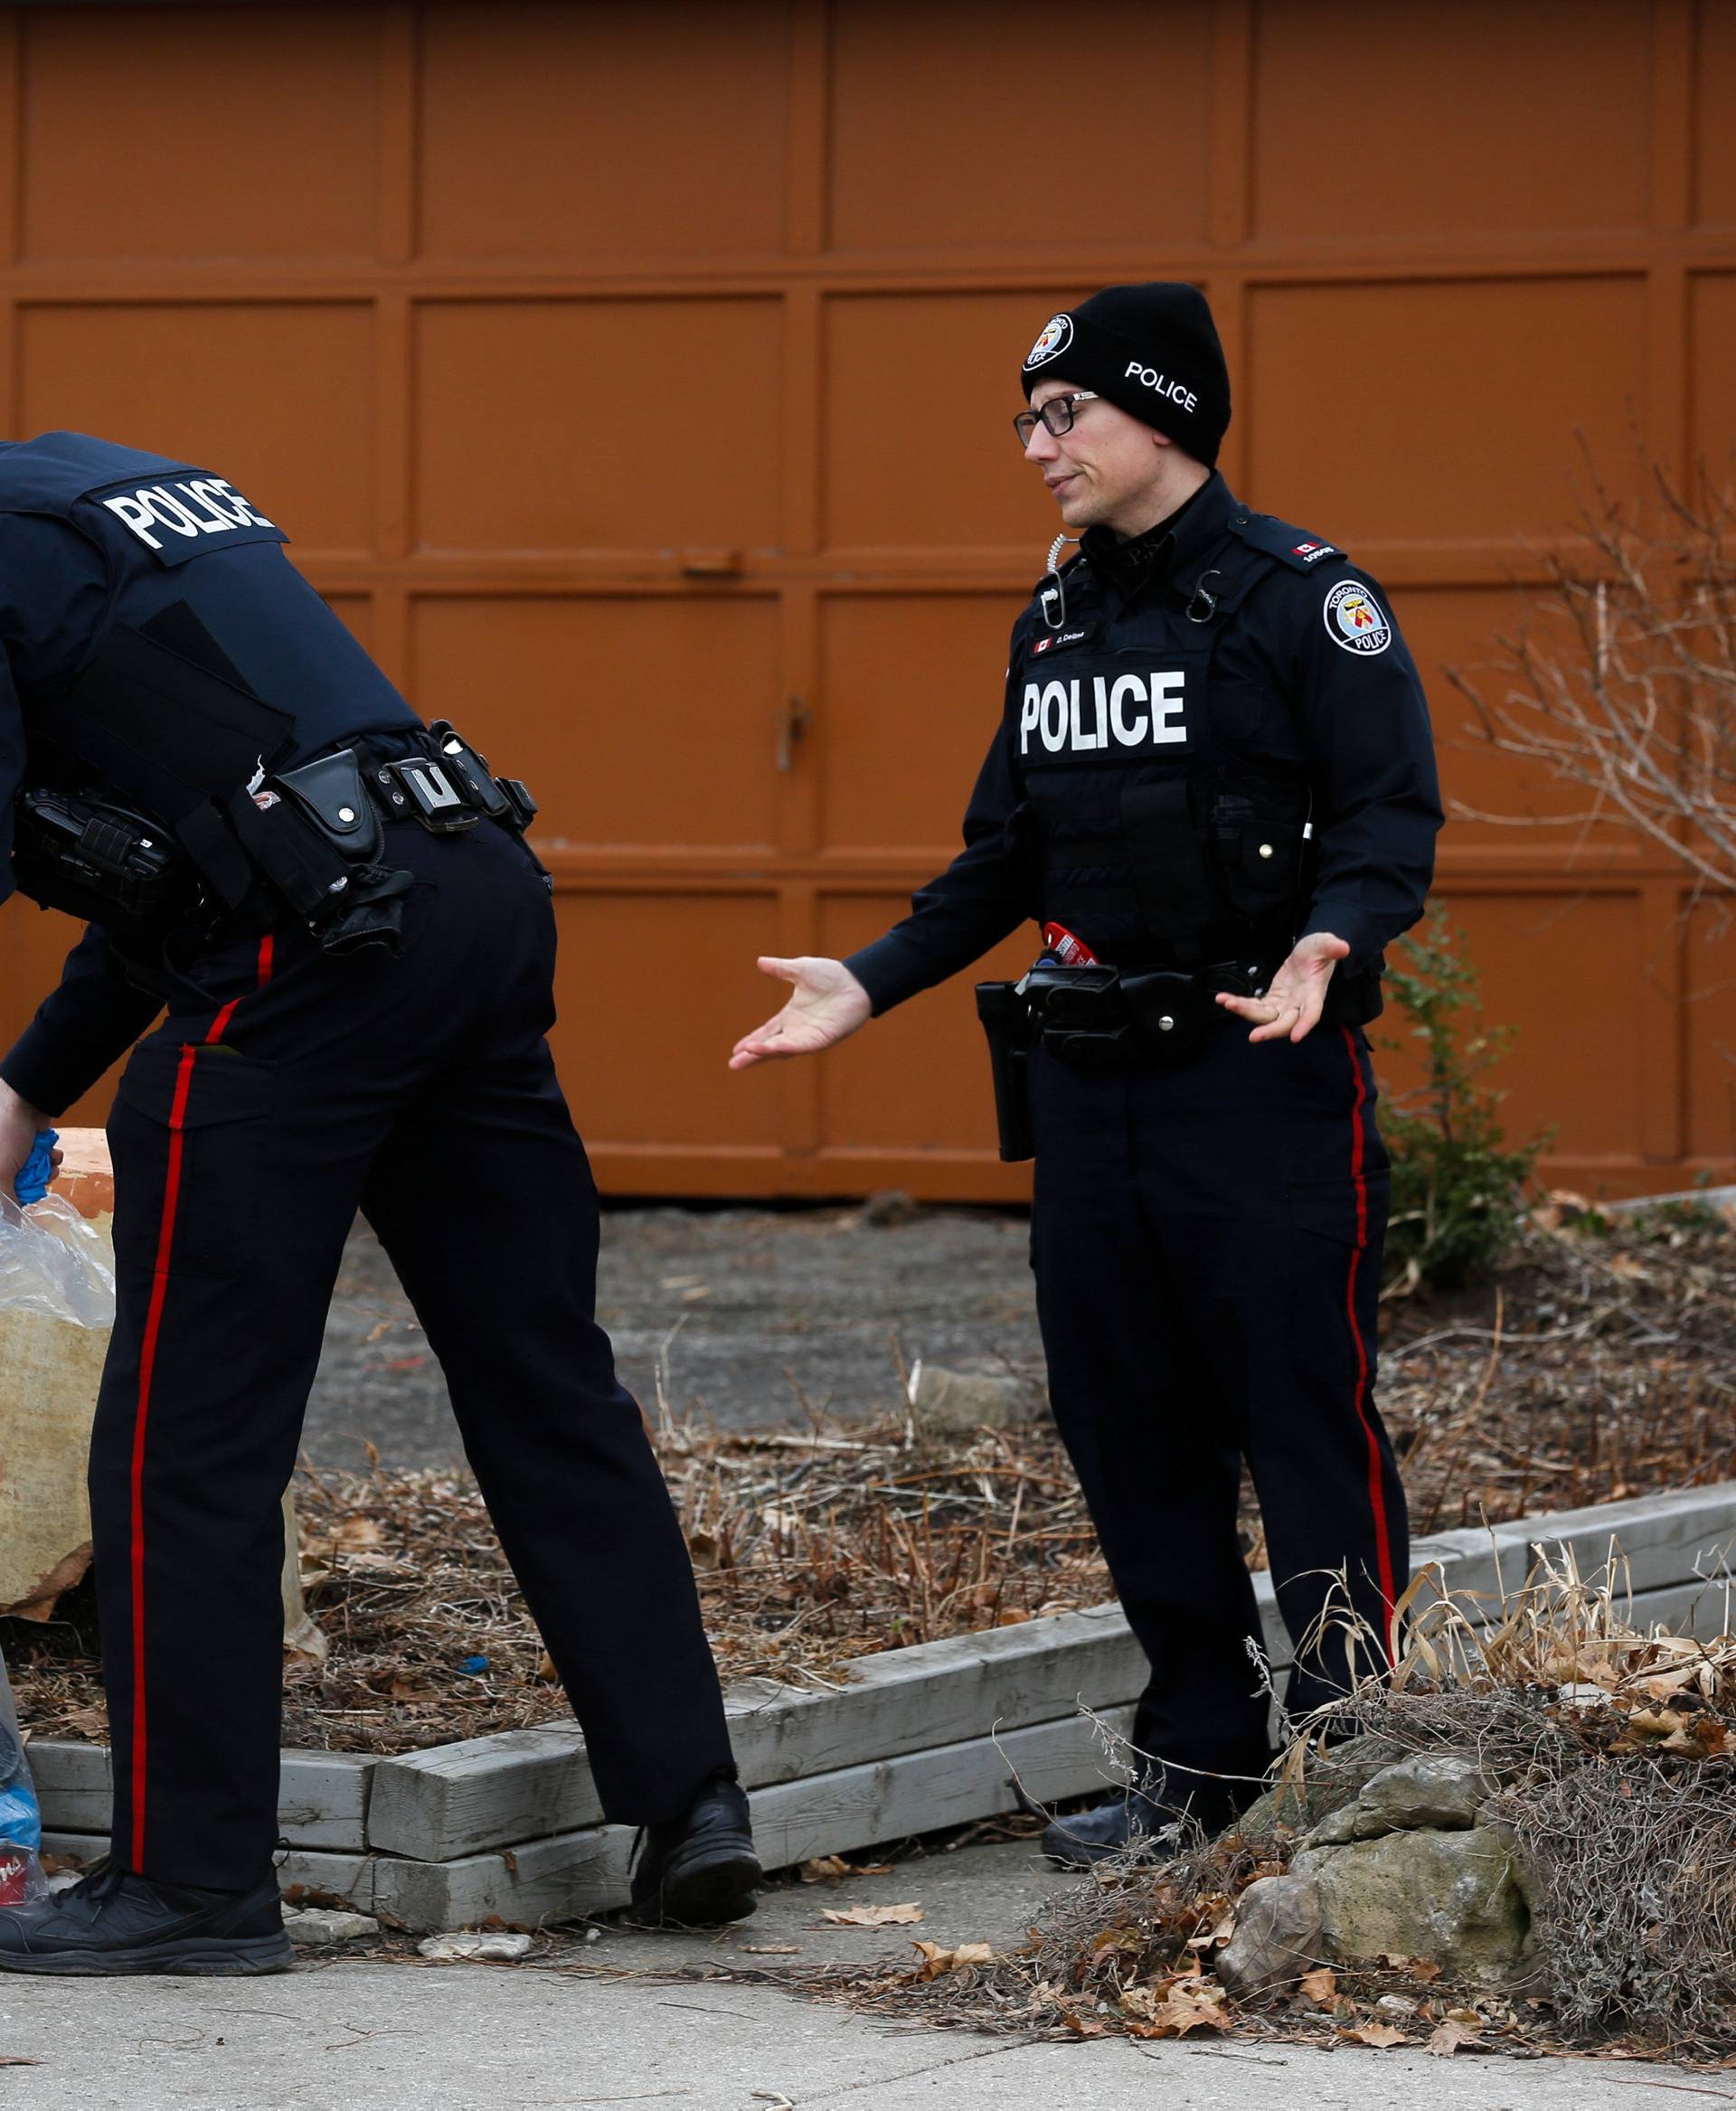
1023, 278, 1229, 468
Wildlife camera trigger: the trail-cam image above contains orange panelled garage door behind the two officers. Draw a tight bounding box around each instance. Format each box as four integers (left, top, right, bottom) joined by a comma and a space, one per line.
0, 0, 1736, 1197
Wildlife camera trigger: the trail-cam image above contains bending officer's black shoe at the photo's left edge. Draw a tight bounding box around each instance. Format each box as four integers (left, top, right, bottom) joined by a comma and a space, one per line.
0, 1861, 296, 1978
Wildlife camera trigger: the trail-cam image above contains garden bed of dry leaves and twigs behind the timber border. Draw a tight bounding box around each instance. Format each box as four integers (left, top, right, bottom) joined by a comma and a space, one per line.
0, 1202, 1736, 1754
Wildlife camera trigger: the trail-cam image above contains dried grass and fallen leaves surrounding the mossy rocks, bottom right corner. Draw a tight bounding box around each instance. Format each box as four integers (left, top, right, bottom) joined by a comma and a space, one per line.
809, 1560, 1736, 2065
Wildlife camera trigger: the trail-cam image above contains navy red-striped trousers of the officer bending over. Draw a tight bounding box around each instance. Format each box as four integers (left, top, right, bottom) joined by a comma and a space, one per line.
90, 824, 731, 1887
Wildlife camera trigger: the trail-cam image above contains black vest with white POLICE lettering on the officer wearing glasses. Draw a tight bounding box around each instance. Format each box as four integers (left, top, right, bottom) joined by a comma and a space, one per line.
1009, 513, 1312, 966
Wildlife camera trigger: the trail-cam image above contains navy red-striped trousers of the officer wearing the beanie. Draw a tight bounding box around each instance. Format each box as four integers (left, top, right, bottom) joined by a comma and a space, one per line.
1031, 1015, 1409, 1788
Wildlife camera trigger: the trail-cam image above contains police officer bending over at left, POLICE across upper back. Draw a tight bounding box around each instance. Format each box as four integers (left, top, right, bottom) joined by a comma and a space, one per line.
0, 433, 759, 1974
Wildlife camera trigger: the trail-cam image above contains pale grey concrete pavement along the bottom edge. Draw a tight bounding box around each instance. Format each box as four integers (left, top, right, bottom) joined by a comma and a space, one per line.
0, 1964, 1697, 2111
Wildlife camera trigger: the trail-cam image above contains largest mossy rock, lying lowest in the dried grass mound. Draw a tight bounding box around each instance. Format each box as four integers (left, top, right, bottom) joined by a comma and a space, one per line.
1292, 1826, 1531, 1978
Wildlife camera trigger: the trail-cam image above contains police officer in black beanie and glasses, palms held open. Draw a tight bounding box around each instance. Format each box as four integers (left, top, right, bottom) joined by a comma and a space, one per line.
733, 283, 1440, 1864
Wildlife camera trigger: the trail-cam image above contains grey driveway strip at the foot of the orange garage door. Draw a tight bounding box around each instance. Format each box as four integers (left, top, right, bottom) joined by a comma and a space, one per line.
307, 1208, 1042, 1465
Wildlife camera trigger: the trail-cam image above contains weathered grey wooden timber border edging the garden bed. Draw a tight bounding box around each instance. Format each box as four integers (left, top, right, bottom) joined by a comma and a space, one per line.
30, 1482, 1736, 1934
